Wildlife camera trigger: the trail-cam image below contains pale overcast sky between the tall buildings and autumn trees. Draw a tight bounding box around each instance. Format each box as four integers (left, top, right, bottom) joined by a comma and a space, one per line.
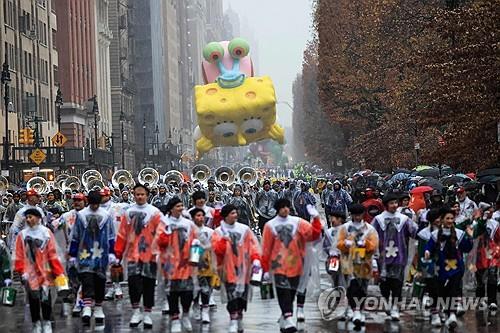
224, 0, 312, 127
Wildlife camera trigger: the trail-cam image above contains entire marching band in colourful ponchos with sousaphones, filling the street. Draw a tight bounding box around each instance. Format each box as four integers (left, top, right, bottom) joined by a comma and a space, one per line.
0, 165, 500, 333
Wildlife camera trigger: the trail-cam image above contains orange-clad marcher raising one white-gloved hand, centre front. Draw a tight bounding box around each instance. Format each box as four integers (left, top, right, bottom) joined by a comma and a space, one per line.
262, 199, 322, 333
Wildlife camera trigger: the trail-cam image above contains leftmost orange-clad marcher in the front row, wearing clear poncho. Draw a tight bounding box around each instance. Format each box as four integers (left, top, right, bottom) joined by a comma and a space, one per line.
14, 208, 65, 333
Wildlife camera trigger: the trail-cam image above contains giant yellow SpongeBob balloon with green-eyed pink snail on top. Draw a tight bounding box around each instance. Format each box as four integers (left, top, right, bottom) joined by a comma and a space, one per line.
195, 38, 284, 155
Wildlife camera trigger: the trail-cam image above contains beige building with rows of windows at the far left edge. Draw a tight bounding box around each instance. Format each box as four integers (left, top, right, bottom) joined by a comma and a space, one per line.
0, 0, 58, 163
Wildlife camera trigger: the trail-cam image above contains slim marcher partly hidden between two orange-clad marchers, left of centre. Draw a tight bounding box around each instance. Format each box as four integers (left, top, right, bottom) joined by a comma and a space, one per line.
190, 208, 217, 324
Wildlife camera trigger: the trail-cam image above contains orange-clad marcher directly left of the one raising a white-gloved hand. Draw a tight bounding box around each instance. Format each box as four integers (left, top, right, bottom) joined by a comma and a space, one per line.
212, 205, 261, 333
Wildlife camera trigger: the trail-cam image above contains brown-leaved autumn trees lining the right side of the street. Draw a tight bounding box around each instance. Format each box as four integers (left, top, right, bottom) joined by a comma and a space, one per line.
294, 0, 500, 171
